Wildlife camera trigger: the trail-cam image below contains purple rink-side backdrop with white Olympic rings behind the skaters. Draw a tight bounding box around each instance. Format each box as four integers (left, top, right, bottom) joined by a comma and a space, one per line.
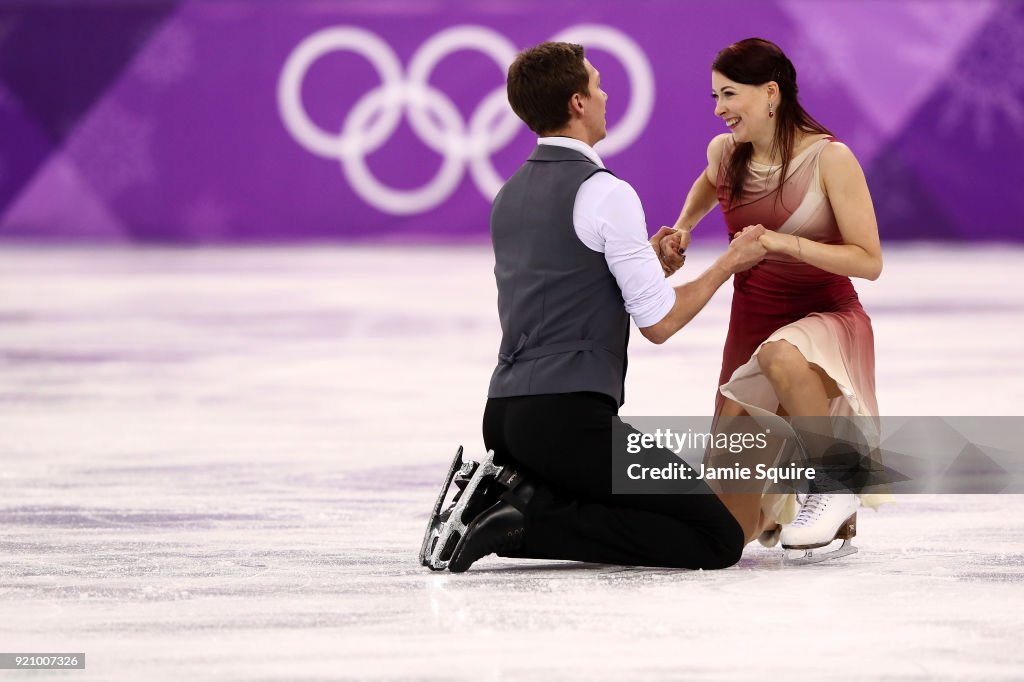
0, 0, 1024, 243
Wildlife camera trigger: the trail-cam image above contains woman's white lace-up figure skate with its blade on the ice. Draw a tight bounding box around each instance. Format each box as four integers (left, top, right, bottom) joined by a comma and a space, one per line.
781, 494, 857, 565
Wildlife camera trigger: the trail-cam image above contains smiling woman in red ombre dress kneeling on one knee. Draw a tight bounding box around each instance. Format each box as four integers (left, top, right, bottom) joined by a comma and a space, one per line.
658, 38, 884, 551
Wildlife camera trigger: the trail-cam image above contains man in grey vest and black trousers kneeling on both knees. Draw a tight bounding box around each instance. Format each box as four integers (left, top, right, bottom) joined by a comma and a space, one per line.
421, 43, 765, 572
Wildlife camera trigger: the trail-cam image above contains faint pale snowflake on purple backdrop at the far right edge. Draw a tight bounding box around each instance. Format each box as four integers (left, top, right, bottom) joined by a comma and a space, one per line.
939, 8, 1024, 147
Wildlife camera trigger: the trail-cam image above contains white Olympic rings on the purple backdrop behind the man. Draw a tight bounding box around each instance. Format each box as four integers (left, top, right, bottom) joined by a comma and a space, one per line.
278, 25, 654, 215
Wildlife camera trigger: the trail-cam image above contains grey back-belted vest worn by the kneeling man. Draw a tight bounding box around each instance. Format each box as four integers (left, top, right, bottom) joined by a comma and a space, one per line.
487, 144, 630, 404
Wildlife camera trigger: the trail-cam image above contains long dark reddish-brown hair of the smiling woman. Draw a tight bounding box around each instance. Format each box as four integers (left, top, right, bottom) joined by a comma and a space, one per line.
711, 38, 831, 204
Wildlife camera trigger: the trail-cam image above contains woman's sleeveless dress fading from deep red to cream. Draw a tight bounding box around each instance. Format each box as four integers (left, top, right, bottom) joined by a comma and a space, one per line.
716, 137, 888, 509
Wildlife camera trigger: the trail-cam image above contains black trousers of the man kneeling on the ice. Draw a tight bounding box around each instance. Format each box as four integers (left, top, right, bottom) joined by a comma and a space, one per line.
483, 393, 743, 568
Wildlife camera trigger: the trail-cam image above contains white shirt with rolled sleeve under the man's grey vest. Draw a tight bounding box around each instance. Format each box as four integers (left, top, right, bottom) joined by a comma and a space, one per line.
537, 137, 676, 328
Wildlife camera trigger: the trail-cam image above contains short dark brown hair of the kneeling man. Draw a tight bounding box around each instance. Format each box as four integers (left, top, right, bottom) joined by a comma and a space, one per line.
507, 43, 590, 135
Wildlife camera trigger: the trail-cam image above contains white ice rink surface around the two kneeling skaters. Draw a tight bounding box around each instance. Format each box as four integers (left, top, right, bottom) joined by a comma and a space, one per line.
0, 246, 1024, 680
